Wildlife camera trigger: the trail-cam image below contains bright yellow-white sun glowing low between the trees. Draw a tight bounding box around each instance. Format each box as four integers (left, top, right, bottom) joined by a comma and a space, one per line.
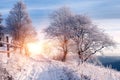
27, 40, 53, 57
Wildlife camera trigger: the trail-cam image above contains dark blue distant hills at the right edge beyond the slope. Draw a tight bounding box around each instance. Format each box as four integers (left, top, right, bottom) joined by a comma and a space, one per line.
98, 56, 120, 71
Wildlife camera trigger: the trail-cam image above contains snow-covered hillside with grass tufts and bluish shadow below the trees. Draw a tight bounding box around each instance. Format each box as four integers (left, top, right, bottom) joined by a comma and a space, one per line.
1, 55, 120, 80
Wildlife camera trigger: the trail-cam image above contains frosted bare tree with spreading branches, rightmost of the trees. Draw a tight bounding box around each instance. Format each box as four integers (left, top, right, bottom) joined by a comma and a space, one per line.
69, 15, 114, 62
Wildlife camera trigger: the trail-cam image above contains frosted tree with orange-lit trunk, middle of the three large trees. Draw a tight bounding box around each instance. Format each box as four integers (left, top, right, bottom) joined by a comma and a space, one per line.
45, 7, 72, 61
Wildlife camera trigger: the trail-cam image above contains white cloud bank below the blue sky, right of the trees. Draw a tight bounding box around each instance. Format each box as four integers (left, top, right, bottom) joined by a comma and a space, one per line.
93, 19, 120, 43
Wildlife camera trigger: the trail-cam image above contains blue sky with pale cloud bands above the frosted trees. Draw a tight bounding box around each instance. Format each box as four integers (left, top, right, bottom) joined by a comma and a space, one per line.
0, 0, 120, 55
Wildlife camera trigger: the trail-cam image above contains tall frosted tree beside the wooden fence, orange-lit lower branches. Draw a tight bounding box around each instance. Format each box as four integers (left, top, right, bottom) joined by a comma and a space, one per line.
6, 1, 36, 54
